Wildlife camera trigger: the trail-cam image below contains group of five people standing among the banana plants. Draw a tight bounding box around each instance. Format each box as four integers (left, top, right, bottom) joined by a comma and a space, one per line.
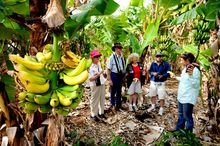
89, 43, 200, 131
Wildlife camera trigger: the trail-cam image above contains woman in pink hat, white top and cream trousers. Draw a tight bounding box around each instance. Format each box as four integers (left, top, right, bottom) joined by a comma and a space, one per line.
88, 50, 106, 121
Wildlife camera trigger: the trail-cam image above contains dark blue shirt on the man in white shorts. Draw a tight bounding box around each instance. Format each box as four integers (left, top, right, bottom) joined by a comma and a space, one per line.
149, 61, 170, 82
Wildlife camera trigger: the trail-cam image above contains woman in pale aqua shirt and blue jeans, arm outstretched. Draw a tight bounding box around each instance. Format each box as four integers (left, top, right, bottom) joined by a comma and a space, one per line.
171, 53, 200, 132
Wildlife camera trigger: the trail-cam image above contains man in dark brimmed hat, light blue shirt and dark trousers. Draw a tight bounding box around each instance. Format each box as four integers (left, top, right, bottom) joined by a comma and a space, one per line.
107, 43, 126, 110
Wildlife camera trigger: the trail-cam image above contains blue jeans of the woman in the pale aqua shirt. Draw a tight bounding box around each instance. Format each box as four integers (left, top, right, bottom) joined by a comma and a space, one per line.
176, 102, 194, 132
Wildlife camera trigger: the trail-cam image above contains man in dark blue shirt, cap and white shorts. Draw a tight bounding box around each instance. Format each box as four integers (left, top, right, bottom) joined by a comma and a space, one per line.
147, 52, 170, 115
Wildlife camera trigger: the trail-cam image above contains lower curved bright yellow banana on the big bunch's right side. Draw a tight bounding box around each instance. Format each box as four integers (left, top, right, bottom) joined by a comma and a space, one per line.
63, 70, 89, 85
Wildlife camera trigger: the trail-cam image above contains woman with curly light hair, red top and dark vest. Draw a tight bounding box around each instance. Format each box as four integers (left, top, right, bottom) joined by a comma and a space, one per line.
126, 53, 145, 111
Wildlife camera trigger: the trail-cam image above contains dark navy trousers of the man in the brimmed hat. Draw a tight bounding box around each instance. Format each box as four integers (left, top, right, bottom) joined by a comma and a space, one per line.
110, 72, 123, 107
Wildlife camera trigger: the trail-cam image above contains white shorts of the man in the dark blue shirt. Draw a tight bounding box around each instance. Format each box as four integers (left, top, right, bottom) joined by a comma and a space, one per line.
149, 81, 166, 99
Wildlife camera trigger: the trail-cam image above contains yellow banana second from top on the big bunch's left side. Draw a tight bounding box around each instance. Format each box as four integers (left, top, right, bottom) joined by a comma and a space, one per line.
17, 71, 47, 85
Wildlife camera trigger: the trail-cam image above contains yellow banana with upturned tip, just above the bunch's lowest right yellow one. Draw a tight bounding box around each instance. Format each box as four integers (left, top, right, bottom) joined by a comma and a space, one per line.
64, 58, 86, 76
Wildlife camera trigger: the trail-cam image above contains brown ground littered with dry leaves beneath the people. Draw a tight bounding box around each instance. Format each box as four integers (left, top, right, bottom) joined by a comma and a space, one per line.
65, 80, 220, 146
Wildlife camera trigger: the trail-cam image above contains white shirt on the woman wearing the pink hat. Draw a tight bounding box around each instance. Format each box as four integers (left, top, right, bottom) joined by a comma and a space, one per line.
89, 63, 105, 87
